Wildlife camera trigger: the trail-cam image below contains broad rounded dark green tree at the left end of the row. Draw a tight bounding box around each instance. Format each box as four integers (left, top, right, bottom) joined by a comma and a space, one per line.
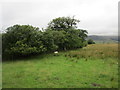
2, 25, 46, 58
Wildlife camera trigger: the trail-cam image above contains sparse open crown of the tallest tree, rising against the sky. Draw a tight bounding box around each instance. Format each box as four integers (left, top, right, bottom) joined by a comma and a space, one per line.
47, 17, 80, 31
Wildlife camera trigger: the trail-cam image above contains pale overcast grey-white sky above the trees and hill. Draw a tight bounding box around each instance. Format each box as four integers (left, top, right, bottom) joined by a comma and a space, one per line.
0, 0, 119, 35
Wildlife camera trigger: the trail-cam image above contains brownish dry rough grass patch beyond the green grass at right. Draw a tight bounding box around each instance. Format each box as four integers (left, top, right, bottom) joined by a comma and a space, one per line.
66, 44, 118, 59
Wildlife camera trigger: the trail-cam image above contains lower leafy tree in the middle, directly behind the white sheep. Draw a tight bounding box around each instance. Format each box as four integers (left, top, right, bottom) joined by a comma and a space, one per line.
42, 30, 65, 52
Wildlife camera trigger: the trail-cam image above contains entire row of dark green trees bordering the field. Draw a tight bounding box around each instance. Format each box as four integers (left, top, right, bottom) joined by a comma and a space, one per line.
2, 17, 88, 59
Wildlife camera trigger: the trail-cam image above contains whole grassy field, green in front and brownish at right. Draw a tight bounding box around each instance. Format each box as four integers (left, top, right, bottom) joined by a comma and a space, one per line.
2, 44, 118, 88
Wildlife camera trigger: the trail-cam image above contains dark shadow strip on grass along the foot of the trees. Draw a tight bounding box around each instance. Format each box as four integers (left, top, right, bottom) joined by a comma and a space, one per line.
2, 49, 77, 62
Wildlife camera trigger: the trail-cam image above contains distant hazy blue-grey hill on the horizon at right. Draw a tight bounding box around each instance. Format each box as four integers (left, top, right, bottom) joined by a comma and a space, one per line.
87, 35, 120, 43
